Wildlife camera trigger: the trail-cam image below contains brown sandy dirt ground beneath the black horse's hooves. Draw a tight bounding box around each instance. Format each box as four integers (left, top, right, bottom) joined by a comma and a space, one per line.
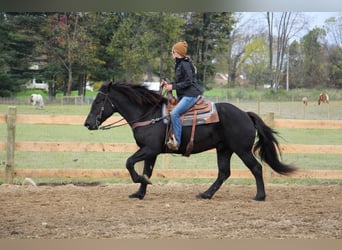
0, 183, 342, 239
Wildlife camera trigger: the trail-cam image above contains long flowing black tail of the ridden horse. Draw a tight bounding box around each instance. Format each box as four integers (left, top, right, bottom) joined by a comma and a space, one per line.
247, 112, 296, 175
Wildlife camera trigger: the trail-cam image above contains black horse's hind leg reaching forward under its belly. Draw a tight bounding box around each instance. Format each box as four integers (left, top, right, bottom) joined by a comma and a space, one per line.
196, 149, 233, 199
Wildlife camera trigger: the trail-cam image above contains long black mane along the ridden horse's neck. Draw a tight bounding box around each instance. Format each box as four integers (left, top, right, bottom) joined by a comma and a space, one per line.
111, 82, 167, 106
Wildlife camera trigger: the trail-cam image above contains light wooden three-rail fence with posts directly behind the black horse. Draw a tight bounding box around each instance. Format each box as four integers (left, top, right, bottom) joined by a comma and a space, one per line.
0, 107, 342, 183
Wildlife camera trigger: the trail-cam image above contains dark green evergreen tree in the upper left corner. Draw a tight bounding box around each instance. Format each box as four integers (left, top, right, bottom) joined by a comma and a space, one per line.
0, 13, 43, 96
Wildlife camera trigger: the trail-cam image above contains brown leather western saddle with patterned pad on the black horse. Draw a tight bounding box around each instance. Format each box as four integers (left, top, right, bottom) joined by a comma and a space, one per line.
163, 93, 220, 156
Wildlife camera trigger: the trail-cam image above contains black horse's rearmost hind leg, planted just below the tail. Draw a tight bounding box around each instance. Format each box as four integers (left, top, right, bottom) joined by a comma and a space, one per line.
238, 152, 266, 201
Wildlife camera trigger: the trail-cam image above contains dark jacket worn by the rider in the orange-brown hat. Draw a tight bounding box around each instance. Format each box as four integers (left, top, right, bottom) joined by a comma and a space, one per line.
172, 57, 203, 99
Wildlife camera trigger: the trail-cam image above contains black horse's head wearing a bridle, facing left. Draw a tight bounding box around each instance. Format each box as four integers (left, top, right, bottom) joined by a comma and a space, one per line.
84, 82, 117, 130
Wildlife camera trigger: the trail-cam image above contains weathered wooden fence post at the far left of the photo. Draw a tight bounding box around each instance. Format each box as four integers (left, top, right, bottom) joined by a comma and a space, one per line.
5, 106, 17, 184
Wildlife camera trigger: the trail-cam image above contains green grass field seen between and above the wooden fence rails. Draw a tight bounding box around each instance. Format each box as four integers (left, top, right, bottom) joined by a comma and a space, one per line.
0, 102, 342, 186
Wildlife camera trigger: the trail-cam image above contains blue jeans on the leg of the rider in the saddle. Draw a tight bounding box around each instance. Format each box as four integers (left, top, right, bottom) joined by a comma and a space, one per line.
170, 96, 197, 145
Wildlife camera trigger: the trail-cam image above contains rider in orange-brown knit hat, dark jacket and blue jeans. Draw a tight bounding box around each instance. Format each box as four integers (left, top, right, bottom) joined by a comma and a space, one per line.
161, 41, 203, 151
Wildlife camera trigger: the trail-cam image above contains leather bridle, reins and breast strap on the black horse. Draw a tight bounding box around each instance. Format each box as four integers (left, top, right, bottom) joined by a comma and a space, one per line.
96, 91, 169, 130
